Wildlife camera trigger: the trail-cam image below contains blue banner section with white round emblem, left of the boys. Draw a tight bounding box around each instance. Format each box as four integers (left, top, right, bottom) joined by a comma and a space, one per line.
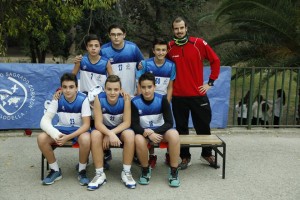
0, 63, 74, 129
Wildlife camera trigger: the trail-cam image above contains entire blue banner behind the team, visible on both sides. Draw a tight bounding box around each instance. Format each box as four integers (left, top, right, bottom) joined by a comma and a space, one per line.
0, 63, 231, 129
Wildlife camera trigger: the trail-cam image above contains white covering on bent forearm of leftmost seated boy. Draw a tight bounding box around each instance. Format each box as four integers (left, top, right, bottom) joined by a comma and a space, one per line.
40, 112, 61, 140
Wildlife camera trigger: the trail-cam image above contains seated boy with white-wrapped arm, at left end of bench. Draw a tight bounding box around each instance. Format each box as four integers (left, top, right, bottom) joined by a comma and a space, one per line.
37, 73, 91, 185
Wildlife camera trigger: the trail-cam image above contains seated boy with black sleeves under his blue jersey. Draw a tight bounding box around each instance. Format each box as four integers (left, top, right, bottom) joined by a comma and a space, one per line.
131, 72, 180, 187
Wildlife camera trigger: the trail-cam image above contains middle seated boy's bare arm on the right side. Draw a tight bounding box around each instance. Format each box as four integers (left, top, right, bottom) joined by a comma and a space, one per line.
112, 94, 131, 134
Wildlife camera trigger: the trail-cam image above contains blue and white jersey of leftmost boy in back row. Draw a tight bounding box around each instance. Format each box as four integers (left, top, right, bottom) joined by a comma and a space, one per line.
80, 55, 108, 92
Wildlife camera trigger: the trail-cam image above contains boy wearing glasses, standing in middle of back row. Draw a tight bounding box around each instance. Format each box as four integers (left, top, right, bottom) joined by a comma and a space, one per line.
100, 24, 144, 97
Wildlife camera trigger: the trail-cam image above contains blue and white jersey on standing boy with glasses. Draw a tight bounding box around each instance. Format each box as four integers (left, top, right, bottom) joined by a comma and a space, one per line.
100, 40, 144, 97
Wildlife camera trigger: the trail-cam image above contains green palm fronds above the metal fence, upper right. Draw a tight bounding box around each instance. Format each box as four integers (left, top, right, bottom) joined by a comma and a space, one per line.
210, 0, 300, 72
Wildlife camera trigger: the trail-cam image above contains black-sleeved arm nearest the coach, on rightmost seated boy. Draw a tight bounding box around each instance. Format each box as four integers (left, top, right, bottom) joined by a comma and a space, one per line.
154, 98, 173, 135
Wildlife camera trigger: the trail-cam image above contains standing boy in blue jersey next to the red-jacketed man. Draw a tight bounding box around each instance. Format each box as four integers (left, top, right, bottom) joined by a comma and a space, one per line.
136, 38, 176, 169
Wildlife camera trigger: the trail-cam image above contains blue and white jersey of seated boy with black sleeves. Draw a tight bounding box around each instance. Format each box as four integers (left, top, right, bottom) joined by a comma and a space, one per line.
132, 93, 165, 129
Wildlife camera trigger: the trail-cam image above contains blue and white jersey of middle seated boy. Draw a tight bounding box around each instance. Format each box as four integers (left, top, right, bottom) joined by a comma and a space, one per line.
98, 92, 125, 129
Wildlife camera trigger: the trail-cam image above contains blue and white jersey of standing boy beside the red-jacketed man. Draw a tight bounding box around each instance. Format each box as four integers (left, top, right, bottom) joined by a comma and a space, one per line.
137, 57, 176, 95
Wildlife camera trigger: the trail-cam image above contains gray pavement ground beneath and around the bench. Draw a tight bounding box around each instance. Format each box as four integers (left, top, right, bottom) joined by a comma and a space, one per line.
0, 128, 300, 200
